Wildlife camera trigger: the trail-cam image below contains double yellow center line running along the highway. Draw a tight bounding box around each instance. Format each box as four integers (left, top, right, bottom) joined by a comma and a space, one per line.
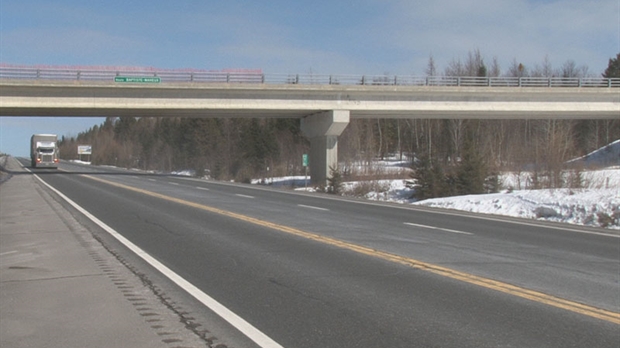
82, 175, 620, 324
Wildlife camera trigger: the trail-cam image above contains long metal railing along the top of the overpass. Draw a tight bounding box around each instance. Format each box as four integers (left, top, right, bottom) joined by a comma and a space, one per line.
0, 66, 620, 88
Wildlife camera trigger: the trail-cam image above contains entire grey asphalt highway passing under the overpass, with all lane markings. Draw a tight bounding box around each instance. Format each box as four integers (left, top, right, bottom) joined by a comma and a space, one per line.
24, 163, 620, 348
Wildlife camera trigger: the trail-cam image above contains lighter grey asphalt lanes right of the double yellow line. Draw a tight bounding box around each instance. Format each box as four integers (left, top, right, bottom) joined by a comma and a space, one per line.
55, 159, 620, 311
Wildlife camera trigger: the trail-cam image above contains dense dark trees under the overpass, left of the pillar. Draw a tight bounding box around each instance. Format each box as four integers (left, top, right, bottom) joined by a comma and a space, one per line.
60, 117, 309, 181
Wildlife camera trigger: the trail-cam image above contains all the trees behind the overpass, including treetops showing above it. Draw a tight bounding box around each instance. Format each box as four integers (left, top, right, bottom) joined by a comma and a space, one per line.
60, 50, 620, 198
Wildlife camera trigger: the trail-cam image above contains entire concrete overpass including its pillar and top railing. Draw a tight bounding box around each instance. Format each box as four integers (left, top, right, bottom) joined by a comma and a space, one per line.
0, 66, 620, 183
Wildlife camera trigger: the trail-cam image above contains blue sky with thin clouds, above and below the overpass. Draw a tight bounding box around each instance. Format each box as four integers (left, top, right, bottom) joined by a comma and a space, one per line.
0, 0, 620, 156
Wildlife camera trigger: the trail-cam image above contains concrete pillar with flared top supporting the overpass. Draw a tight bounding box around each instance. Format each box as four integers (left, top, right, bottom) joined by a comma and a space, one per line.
301, 110, 349, 185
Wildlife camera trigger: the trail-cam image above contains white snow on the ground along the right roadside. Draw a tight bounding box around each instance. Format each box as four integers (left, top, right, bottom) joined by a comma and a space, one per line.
263, 167, 620, 230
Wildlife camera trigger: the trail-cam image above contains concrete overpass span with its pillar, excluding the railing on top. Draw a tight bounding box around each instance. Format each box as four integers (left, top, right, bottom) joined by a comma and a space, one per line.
0, 79, 620, 184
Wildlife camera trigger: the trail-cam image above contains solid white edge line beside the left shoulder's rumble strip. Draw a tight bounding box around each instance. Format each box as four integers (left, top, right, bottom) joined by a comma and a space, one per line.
34, 174, 283, 348
